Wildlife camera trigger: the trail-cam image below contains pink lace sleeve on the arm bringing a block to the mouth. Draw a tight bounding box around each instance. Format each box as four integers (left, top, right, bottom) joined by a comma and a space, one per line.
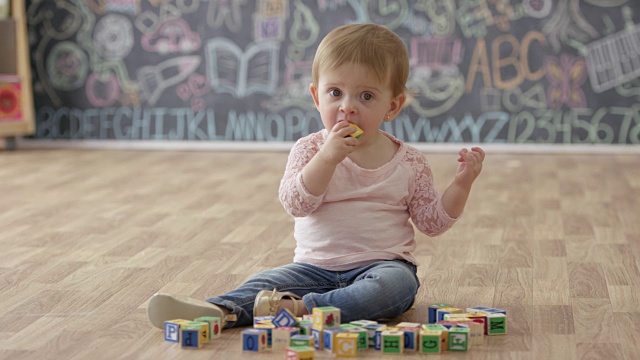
279, 135, 324, 217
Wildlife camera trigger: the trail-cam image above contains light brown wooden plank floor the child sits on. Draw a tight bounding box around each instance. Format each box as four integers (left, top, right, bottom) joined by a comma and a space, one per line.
0, 150, 640, 360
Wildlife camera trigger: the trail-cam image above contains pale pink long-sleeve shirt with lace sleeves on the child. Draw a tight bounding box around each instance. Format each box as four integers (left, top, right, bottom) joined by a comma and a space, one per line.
279, 130, 457, 271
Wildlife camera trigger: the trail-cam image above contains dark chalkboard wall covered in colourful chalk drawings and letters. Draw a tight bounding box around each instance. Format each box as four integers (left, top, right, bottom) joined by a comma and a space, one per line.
27, 0, 640, 144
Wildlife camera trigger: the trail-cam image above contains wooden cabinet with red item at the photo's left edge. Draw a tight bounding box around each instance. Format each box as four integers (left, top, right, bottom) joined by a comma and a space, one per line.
0, 0, 35, 149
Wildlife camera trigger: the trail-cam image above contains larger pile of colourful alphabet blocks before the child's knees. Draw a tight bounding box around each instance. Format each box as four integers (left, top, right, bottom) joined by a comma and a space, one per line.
242, 304, 507, 360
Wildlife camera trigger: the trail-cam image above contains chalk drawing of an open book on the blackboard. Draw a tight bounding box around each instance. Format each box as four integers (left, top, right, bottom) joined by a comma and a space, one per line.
205, 38, 279, 98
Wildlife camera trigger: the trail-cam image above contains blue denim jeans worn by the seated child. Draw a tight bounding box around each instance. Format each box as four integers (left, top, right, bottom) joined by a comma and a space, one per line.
206, 260, 420, 328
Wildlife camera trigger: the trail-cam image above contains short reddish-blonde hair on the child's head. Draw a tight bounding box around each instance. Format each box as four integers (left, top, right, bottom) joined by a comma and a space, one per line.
311, 24, 409, 96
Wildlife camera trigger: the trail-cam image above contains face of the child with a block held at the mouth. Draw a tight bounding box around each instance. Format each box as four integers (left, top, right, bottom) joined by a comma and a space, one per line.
309, 63, 404, 141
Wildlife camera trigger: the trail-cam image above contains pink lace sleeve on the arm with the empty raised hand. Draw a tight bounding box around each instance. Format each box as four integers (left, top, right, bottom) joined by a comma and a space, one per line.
406, 149, 459, 236
